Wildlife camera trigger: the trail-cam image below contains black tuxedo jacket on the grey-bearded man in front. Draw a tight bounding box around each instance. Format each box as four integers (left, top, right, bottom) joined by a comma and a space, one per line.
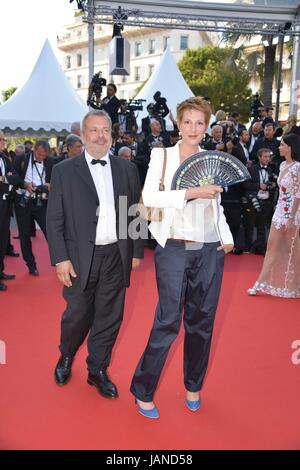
47, 153, 143, 291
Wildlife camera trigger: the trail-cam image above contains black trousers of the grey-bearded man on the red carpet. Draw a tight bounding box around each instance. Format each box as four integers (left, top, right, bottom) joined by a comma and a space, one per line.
60, 243, 126, 374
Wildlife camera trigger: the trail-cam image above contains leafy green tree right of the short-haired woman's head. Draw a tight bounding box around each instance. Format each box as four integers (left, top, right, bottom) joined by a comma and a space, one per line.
178, 46, 252, 122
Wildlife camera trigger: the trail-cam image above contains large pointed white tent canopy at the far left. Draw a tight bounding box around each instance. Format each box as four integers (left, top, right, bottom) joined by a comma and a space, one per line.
0, 39, 88, 135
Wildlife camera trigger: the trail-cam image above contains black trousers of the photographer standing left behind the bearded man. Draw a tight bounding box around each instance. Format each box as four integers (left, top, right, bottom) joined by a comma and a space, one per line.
15, 195, 47, 268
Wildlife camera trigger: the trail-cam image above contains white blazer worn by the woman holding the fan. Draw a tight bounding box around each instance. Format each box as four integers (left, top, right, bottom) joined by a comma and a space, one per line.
143, 142, 233, 247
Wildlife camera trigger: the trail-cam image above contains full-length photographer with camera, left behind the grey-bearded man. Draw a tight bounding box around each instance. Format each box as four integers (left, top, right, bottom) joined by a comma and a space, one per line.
14, 140, 55, 276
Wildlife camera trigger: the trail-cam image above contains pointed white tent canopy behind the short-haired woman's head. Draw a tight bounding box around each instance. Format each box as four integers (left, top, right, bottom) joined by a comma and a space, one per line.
135, 47, 194, 129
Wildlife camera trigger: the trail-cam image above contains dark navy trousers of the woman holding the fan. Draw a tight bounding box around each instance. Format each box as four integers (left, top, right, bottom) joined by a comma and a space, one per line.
130, 240, 224, 402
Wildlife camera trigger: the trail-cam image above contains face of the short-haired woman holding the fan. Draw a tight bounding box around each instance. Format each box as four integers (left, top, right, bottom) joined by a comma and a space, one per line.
179, 109, 207, 145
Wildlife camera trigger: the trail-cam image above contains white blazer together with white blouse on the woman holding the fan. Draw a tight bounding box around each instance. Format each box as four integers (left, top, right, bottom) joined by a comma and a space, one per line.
143, 142, 233, 247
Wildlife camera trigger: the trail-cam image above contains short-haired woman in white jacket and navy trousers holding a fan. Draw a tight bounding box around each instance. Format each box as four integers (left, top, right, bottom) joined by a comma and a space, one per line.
131, 97, 233, 418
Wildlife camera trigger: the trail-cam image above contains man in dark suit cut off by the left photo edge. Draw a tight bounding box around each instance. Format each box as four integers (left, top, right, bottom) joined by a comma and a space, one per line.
0, 131, 18, 291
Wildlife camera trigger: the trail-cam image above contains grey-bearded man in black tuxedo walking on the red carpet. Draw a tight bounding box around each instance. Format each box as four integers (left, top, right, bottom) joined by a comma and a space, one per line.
47, 110, 143, 398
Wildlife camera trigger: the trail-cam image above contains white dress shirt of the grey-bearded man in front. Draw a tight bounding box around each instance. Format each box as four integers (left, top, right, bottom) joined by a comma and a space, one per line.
85, 150, 118, 245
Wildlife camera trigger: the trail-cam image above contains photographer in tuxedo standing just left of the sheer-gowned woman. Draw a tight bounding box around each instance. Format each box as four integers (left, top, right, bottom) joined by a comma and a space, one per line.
244, 148, 276, 255
